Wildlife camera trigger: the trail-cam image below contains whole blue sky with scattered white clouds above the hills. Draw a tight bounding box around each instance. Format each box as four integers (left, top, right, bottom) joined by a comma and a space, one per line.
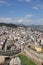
0, 0, 43, 25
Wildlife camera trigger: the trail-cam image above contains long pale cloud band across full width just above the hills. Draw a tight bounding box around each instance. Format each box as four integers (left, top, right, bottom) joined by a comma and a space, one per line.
0, 15, 43, 25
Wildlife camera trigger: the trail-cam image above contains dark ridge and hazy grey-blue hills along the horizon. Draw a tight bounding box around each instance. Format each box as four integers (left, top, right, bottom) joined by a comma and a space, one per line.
0, 23, 43, 32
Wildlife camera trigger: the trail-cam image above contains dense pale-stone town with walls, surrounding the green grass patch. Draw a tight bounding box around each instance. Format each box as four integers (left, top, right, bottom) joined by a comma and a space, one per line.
0, 26, 43, 65
